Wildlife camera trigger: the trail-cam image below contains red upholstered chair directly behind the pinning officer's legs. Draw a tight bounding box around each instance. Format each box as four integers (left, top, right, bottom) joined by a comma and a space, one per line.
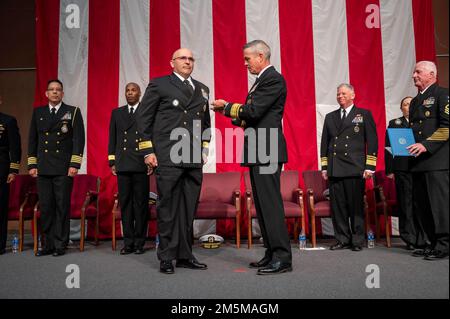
244, 171, 305, 248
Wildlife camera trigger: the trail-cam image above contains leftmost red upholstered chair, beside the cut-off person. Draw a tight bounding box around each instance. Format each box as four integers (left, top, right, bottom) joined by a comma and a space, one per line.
8, 175, 37, 251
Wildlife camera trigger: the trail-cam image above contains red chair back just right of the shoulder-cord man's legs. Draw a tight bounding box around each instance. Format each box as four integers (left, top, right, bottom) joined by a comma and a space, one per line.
70, 174, 100, 218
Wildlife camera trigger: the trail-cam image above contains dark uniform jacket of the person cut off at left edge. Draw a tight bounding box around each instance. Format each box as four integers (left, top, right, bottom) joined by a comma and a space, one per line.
0, 112, 21, 176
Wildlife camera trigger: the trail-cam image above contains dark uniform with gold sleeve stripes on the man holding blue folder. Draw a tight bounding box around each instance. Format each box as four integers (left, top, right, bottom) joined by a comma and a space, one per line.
409, 84, 449, 256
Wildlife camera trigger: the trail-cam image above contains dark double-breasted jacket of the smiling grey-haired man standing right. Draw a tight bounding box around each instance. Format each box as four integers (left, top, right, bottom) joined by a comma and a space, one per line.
320, 105, 378, 177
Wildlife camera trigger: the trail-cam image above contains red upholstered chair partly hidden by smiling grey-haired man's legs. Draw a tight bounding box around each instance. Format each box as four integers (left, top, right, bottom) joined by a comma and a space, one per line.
303, 171, 331, 247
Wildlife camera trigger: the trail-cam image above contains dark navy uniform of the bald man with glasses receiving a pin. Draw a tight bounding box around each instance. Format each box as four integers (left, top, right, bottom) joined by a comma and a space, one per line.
137, 73, 211, 261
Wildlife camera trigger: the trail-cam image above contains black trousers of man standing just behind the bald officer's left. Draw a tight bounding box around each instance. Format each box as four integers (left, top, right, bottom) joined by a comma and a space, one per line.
117, 172, 149, 248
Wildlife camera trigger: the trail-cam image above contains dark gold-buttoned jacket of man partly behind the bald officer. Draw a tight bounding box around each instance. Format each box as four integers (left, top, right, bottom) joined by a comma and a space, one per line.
108, 105, 147, 172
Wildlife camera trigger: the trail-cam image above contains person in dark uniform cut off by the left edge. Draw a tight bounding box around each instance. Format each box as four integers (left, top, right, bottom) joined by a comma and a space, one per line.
0, 96, 21, 255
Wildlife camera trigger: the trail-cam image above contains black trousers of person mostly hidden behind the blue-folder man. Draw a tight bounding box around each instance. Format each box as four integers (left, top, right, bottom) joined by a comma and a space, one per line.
395, 171, 425, 247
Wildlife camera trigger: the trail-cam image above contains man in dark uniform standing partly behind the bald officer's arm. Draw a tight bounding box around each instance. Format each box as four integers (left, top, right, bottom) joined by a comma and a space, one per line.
108, 83, 149, 255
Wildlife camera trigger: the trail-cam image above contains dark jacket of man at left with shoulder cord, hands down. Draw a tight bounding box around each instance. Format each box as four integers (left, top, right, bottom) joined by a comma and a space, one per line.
28, 103, 85, 175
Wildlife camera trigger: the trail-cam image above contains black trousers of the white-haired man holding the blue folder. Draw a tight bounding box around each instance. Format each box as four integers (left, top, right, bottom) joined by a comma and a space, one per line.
413, 171, 449, 253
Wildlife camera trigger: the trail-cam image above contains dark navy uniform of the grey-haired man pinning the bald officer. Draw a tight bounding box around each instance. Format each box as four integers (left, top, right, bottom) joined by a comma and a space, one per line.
224, 66, 292, 268
